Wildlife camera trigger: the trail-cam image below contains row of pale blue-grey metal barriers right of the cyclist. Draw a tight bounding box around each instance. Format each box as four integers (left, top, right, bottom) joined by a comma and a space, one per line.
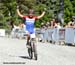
37, 28, 75, 45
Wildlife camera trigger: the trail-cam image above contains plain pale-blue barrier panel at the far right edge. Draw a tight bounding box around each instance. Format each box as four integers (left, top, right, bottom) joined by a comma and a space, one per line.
65, 28, 75, 45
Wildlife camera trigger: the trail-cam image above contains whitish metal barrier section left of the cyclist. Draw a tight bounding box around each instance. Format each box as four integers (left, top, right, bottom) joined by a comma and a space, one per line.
5, 28, 26, 38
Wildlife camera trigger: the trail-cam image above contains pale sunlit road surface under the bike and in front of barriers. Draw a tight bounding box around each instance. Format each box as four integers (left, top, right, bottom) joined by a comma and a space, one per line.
0, 38, 75, 65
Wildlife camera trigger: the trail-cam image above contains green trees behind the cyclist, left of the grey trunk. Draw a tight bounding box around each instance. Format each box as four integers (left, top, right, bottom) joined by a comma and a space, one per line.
0, 0, 59, 27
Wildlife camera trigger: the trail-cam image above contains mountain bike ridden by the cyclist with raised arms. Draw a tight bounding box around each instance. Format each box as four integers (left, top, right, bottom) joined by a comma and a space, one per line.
28, 38, 37, 60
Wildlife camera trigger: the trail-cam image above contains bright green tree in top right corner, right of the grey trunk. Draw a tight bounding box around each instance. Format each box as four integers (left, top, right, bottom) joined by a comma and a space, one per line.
64, 0, 75, 23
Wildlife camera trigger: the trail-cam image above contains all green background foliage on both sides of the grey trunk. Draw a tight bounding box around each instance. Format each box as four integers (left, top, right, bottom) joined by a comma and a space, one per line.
0, 0, 75, 28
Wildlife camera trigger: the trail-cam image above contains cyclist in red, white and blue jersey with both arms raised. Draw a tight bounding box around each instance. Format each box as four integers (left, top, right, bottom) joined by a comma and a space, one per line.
17, 7, 45, 47
